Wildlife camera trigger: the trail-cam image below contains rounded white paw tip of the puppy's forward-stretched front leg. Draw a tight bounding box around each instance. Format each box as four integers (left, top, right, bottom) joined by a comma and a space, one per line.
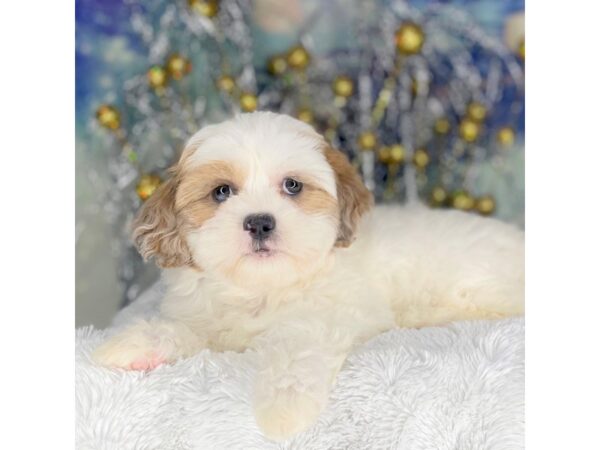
254, 388, 324, 440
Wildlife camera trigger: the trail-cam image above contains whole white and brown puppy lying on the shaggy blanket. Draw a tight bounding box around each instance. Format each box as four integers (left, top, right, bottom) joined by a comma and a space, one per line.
94, 112, 524, 439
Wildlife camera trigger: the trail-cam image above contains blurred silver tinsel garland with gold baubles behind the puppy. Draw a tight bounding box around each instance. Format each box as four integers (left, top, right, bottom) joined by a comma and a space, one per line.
90, 0, 524, 304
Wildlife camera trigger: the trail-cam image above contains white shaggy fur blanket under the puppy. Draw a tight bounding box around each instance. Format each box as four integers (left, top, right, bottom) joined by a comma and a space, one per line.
76, 286, 524, 450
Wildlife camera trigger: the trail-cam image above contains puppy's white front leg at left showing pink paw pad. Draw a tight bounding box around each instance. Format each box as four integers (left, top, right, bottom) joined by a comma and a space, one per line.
92, 318, 204, 370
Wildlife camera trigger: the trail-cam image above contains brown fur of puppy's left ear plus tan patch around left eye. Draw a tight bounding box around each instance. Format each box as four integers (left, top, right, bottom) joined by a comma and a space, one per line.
133, 162, 243, 268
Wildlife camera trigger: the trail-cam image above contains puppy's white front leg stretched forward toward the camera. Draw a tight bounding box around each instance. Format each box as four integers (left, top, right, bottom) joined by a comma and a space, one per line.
253, 322, 349, 440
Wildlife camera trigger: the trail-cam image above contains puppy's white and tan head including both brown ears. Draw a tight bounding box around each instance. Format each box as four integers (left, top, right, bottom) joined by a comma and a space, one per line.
134, 112, 371, 288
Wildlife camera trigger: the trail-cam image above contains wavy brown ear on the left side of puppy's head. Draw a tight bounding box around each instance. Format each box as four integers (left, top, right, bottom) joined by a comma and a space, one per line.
133, 178, 192, 268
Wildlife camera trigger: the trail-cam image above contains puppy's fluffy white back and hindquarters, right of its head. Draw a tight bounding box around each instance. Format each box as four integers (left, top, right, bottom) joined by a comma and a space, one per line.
347, 205, 524, 327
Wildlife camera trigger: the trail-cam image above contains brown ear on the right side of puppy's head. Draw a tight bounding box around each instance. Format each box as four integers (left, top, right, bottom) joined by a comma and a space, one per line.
325, 146, 373, 247
